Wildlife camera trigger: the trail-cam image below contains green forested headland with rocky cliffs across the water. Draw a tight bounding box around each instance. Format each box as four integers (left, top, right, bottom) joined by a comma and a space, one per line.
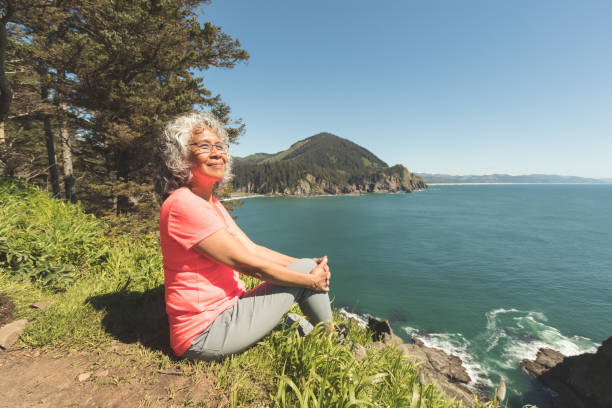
233, 133, 427, 195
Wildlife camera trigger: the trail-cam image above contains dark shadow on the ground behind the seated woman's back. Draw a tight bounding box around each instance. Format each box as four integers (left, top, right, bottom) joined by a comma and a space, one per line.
86, 285, 173, 356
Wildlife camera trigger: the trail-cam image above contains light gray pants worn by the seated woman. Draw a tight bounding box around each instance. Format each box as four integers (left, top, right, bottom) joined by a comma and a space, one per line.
183, 258, 332, 360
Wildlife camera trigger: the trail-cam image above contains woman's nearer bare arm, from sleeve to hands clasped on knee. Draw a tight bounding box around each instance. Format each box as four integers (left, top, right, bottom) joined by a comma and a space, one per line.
194, 228, 330, 292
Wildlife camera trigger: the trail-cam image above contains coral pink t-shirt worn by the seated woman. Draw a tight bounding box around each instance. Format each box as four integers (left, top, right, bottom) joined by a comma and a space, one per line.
159, 188, 245, 356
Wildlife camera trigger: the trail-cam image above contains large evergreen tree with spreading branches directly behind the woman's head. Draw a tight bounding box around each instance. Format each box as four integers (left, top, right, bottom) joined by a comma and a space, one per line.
4, 0, 248, 220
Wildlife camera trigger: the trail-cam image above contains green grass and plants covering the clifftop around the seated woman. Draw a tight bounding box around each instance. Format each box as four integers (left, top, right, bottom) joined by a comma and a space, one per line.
0, 180, 502, 408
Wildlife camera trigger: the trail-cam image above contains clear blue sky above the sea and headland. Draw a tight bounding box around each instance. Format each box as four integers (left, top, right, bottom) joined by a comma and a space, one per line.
201, 0, 612, 178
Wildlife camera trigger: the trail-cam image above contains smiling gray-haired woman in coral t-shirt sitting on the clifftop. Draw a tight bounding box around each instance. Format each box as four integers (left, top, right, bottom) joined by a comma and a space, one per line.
160, 113, 332, 360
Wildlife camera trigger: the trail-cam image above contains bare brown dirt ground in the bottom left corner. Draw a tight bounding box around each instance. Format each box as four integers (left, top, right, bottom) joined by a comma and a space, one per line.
0, 342, 228, 408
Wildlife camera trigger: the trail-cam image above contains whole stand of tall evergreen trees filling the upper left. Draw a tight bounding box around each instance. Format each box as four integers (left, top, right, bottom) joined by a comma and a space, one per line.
0, 0, 249, 230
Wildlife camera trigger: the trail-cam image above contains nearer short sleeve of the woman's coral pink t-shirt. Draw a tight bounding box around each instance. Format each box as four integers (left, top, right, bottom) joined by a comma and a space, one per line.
168, 192, 225, 250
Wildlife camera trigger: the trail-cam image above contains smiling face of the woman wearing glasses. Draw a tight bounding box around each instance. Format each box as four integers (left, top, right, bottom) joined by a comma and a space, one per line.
189, 127, 227, 182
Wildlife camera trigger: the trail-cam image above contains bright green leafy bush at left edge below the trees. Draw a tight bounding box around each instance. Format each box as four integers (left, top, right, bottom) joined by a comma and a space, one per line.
0, 179, 108, 290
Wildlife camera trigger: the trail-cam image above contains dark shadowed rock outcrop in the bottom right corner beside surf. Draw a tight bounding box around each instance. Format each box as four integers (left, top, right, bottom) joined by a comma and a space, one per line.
521, 337, 612, 408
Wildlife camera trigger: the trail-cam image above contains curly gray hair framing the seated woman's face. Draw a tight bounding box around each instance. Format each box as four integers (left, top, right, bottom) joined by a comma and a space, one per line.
159, 112, 232, 198
